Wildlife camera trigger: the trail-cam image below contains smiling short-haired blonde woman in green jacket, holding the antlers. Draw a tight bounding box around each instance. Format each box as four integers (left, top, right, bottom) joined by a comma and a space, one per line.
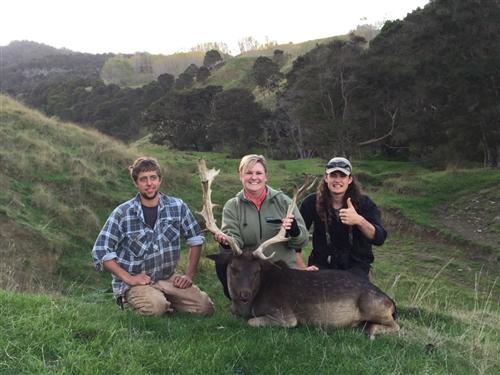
214, 154, 309, 297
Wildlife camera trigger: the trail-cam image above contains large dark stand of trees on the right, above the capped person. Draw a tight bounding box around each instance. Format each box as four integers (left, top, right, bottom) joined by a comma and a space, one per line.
279, 0, 500, 166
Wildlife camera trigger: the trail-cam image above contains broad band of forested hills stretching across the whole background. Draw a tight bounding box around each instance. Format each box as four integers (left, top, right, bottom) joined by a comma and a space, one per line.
0, 0, 500, 167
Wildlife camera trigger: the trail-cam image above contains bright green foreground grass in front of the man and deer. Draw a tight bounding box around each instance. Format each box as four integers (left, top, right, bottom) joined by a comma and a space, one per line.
0, 232, 500, 374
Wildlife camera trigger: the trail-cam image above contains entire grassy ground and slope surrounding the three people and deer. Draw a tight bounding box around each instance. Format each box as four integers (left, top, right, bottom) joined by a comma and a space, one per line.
0, 96, 500, 374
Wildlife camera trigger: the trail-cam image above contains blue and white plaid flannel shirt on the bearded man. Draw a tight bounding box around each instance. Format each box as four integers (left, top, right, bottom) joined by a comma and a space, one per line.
92, 193, 204, 297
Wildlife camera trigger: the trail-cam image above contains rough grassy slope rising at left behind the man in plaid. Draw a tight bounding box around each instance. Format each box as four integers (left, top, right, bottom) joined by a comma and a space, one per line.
0, 95, 134, 289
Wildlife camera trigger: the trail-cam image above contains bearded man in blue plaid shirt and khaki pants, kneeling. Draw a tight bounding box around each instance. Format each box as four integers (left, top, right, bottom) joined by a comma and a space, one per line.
92, 157, 214, 315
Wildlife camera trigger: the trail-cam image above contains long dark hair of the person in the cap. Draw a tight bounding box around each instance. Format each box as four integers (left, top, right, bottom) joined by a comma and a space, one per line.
316, 175, 364, 223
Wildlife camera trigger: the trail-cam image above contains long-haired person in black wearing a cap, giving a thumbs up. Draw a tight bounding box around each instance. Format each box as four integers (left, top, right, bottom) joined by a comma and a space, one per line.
300, 157, 387, 277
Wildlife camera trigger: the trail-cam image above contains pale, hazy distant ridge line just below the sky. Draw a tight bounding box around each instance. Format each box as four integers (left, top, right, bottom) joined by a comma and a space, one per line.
0, 36, 345, 88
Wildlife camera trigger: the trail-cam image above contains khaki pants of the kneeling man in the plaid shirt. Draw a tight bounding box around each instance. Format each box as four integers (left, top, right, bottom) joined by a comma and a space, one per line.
124, 274, 215, 315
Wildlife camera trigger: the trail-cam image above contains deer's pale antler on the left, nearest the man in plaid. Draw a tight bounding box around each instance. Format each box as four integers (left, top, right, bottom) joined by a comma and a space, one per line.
198, 159, 242, 255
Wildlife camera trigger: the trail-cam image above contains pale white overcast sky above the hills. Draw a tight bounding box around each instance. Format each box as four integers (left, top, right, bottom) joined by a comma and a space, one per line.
0, 0, 429, 54
